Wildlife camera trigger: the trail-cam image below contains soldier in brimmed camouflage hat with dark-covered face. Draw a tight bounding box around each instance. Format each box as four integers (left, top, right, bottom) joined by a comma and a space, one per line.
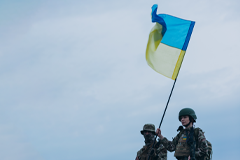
135, 124, 167, 160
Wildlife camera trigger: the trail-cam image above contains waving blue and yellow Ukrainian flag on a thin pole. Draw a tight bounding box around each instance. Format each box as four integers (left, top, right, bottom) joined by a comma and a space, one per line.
146, 4, 195, 80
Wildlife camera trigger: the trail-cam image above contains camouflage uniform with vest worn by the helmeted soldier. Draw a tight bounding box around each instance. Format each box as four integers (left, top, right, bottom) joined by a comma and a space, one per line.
161, 128, 207, 160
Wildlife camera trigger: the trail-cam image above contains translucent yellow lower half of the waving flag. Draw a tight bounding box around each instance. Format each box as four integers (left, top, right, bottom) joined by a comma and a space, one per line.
146, 23, 186, 80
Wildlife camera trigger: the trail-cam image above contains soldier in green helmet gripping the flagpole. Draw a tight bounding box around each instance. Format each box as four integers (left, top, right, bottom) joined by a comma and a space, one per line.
156, 108, 207, 160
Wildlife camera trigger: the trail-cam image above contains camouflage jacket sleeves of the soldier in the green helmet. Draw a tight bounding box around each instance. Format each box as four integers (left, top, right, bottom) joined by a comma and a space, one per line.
160, 128, 207, 159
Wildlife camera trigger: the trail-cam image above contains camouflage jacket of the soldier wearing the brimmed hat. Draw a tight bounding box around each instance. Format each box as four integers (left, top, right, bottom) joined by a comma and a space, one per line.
136, 142, 167, 160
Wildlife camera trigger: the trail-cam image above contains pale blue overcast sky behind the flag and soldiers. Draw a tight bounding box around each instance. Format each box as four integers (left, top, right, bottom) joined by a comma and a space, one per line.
0, 0, 240, 160
